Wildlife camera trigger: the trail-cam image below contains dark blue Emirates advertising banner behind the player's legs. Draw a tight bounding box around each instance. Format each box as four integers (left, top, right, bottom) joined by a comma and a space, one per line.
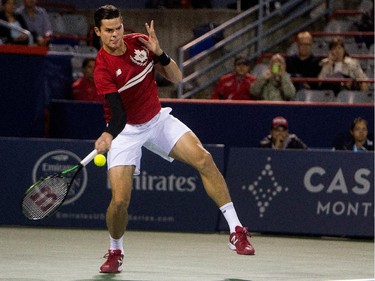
0, 139, 224, 232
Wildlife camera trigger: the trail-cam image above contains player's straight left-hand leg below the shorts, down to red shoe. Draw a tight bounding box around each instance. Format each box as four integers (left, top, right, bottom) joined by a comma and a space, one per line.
100, 166, 135, 273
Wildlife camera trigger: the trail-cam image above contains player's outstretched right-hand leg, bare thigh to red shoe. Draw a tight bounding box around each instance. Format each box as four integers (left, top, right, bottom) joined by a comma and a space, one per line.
169, 132, 255, 255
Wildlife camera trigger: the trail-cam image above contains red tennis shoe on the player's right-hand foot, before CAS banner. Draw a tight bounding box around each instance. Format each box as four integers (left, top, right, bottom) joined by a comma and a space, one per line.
228, 225, 255, 255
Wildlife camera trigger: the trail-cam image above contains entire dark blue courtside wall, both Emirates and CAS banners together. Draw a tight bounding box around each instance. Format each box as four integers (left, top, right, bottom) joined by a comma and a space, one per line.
0, 138, 374, 237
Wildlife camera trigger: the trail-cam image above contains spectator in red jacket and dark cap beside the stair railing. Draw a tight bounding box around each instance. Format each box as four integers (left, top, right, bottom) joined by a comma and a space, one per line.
211, 56, 255, 100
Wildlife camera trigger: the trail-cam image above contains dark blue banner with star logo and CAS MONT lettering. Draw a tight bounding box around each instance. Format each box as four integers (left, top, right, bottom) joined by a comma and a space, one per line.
221, 148, 374, 237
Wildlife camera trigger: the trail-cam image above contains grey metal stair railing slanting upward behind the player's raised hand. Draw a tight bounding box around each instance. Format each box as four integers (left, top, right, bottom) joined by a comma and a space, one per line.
178, 0, 331, 98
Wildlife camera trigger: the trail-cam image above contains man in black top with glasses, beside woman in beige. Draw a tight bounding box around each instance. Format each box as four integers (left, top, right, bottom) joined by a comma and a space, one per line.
285, 31, 321, 90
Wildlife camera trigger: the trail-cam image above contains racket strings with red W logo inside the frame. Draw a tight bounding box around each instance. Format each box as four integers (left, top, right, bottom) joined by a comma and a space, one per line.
22, 176, 69, 220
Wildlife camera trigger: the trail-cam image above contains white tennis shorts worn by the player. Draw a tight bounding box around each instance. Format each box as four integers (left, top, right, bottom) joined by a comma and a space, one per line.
107, 107, 191, 175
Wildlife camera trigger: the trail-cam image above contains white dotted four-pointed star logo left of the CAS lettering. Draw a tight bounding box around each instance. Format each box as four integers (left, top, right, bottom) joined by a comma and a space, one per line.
242, 157, 289, 218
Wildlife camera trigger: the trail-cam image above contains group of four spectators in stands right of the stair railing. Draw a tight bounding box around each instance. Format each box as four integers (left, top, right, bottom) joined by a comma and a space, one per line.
211, 31, 369, 101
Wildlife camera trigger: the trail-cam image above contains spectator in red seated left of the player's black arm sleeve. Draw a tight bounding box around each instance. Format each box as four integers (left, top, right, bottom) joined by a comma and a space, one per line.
72, 58, 104, 102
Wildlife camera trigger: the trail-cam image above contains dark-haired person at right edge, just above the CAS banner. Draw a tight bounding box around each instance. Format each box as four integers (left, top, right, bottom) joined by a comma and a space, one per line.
334, 117, 374, 152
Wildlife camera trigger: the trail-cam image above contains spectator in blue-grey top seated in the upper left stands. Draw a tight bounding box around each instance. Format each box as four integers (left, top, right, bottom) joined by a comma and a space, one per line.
16, 0, 52, 46
